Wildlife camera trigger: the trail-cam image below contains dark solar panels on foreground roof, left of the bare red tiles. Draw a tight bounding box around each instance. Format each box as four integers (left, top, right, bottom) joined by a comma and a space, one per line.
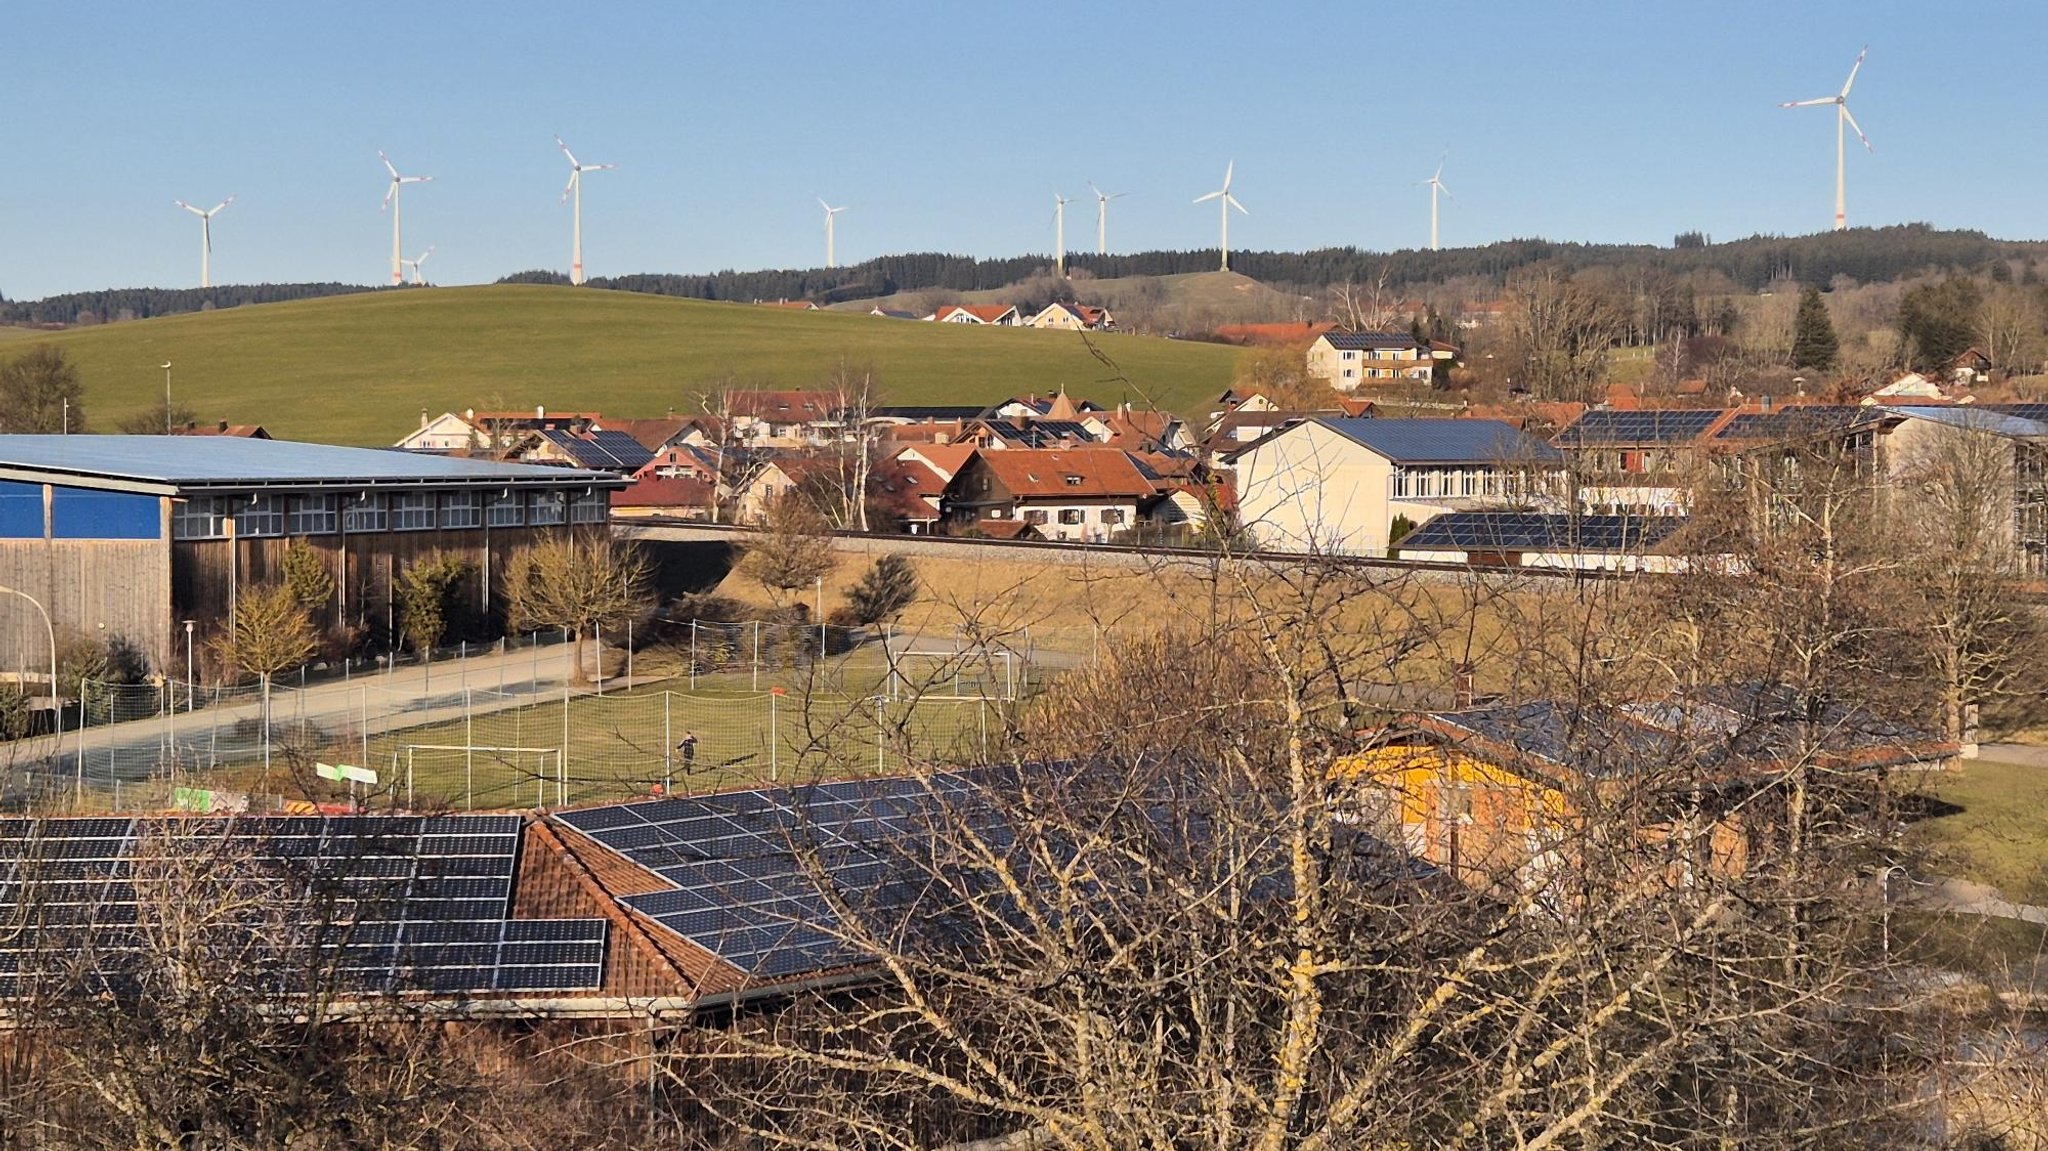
0, 815, 608, 997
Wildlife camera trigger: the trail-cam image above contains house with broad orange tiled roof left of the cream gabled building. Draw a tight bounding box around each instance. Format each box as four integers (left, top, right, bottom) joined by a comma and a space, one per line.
942, 446, 1159, 543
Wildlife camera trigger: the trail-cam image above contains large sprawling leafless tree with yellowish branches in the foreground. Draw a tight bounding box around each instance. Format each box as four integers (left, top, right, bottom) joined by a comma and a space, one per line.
668, 563, 1937, 1151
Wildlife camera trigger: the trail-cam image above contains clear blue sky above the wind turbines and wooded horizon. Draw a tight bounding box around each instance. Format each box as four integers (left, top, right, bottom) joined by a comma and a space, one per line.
0, 0, 2048, 299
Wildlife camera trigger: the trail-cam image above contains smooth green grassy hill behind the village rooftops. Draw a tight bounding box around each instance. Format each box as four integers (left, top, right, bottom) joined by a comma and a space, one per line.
16, 287, 1239, 444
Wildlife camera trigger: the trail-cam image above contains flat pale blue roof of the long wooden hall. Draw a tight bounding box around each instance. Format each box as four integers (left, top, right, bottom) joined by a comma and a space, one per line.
0, 436, 623, 492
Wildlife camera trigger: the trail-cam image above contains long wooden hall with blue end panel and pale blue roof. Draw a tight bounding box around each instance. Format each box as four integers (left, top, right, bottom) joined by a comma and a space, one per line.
0, 436, 625, 672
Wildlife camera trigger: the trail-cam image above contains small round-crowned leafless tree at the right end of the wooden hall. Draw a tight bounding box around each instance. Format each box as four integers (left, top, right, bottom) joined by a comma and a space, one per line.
500, 530, 653, 684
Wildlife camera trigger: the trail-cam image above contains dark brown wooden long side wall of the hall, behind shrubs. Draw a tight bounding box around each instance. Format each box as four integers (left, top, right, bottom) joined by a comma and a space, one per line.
170, 528, 561, 639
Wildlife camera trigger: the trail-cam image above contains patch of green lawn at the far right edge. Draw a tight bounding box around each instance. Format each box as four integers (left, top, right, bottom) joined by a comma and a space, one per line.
1911, 760, 2048, 903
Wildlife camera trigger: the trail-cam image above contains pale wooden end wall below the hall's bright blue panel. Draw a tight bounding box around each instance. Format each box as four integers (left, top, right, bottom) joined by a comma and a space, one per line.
0, 539, 172, 676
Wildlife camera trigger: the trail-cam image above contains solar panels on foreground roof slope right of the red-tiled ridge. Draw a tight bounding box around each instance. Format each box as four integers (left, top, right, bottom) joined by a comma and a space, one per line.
553, 774, 1010, 979
